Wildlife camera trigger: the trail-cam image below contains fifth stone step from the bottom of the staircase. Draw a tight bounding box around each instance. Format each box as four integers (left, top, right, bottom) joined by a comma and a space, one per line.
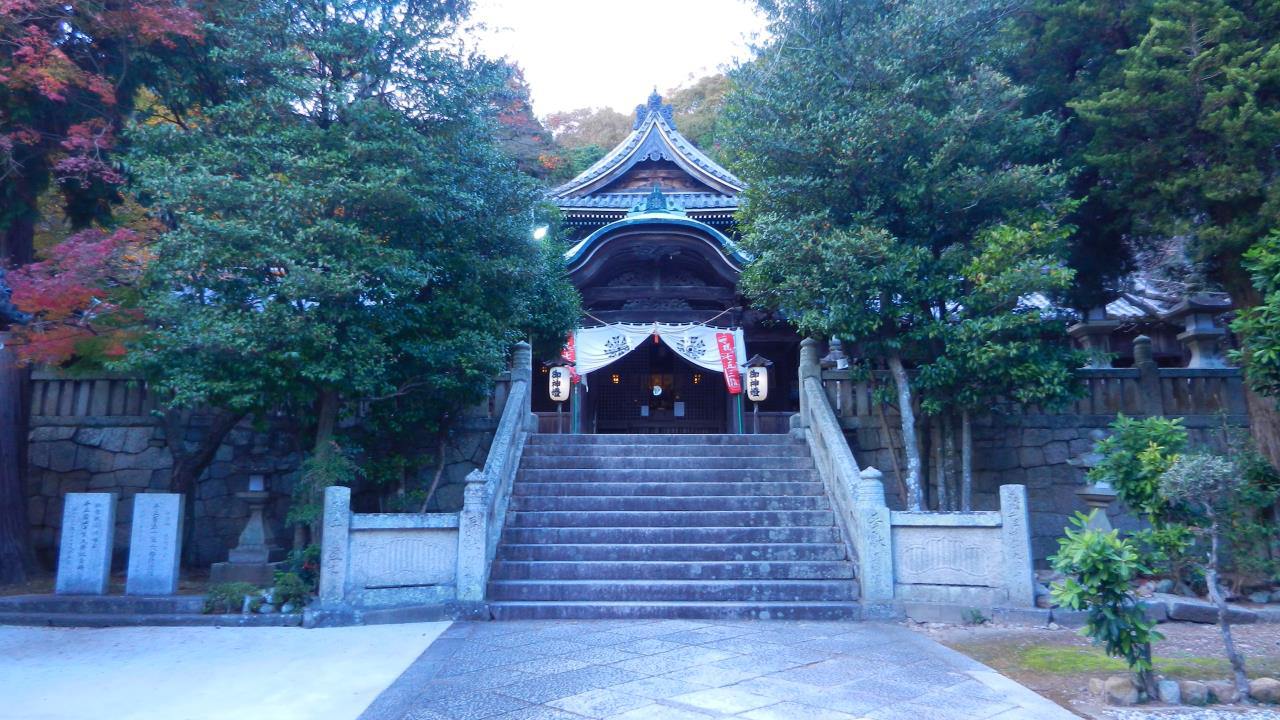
502, 524, 841, 544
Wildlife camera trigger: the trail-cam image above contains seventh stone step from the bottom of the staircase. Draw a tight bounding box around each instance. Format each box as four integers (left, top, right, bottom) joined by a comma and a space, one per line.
511, 495, 831, 512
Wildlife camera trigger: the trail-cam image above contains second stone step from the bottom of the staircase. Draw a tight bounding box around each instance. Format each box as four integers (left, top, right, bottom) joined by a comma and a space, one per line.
488, 580, 858, 602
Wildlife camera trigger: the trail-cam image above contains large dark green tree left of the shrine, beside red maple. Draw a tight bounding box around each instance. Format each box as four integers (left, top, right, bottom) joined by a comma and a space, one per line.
127, 0, 576, 538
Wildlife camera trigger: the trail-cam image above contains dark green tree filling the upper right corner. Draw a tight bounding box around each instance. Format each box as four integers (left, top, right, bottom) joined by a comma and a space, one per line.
1074, 0, 1280, 297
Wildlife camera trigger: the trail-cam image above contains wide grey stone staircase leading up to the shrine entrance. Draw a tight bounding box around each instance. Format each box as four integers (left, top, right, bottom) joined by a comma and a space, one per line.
488, 434, 861, 619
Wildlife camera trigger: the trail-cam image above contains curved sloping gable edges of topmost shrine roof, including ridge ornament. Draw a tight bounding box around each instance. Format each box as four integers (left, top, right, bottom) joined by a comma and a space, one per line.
550, 91, 744, 205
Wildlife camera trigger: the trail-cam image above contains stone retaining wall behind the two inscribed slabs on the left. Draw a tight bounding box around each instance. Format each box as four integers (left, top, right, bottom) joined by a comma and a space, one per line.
27, 372, 504, 569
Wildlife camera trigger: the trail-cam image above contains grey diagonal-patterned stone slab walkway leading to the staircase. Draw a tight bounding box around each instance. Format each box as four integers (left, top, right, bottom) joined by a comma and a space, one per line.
361, 620, 1075, 720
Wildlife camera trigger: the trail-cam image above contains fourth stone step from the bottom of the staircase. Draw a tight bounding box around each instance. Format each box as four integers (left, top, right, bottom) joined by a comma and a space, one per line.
498, 542, 847, 562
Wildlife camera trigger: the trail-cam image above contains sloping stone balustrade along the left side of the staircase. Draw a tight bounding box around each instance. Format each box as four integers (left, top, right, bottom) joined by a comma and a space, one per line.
456, 342, 538, 602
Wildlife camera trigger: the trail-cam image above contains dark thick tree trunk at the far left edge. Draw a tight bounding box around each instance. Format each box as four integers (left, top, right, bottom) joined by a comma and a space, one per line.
0, 332, 36, 585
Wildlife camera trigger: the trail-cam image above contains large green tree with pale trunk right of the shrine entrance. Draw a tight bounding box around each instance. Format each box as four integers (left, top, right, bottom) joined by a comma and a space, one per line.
724, 0, 1065, 507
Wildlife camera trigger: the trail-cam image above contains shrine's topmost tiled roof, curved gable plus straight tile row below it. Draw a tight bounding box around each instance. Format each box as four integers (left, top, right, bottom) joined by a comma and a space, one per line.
550, 91, 744, 203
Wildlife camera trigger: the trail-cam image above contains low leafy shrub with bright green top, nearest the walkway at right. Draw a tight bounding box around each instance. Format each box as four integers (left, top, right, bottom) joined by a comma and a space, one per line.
1050, 512, 1164, 696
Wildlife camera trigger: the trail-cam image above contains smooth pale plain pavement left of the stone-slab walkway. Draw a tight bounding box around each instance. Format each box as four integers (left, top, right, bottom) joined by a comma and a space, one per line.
0, 623, 449, 720
